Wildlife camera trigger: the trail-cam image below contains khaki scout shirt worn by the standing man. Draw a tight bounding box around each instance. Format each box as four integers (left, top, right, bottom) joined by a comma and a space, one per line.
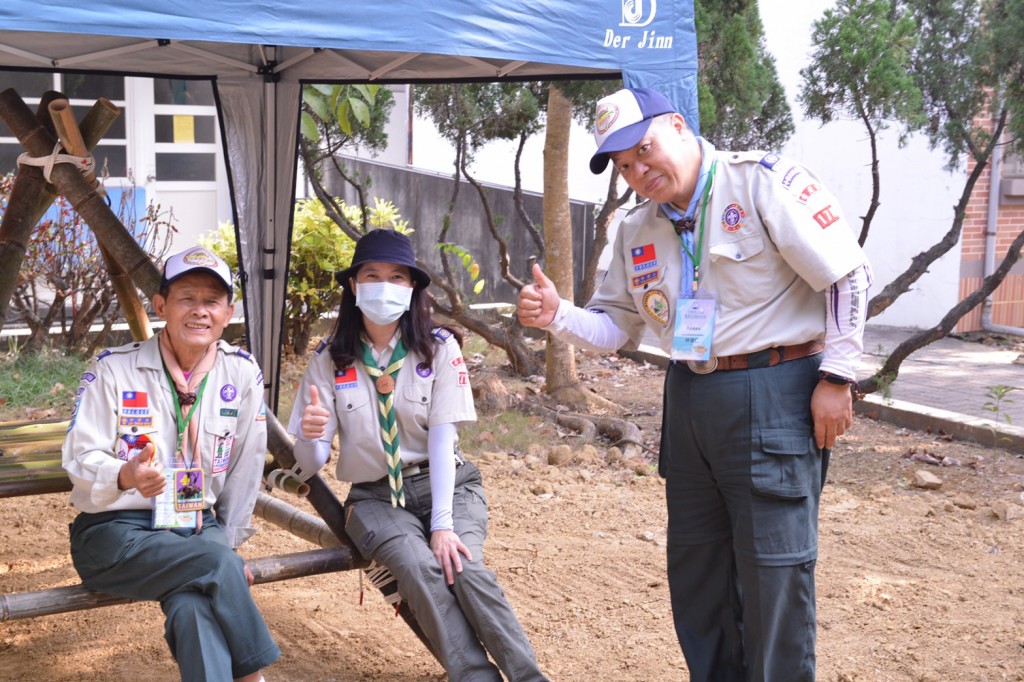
587, 141, 867, 355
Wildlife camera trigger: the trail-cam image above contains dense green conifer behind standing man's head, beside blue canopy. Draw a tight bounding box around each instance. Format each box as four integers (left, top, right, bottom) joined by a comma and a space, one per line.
693, 0, 794, 150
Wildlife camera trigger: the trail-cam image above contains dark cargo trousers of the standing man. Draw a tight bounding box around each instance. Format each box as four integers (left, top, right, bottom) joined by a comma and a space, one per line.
659, 356, 825, 682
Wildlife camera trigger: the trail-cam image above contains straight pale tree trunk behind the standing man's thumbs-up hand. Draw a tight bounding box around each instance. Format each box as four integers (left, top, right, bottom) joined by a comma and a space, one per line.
544, 85, 577, 393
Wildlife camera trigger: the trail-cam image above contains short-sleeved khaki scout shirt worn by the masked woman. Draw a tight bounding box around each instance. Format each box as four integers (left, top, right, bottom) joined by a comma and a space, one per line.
289, 329, 476, 483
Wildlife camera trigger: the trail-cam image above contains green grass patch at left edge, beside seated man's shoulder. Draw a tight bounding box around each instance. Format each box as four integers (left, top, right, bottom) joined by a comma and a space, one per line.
0, 350, 88, 421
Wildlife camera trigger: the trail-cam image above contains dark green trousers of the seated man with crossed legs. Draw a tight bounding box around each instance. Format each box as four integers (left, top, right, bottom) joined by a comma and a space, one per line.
71, 510, 281, 682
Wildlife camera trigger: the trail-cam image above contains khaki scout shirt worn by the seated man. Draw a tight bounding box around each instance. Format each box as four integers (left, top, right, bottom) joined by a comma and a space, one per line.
62, 336, 266, 547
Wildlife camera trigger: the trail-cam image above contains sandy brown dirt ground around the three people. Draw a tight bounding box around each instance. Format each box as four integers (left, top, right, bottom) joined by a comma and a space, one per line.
0, 348, 1024, 682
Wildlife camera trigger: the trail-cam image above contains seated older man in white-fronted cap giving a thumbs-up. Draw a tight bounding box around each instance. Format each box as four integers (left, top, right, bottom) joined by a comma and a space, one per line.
63, 247, 281, 682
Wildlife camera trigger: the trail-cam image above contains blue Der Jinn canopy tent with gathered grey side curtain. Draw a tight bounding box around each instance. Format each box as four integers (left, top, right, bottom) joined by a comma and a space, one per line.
0, 0, 697, 400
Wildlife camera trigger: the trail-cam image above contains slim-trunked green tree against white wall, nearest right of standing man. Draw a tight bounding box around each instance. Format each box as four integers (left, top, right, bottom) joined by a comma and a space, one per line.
800, 0, 927, 246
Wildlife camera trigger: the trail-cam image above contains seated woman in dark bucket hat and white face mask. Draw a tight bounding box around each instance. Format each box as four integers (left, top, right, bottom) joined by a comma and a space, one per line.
289, 229, 545, 682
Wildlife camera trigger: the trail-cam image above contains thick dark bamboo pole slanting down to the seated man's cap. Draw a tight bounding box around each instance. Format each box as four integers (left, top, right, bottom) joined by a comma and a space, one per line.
0, 88, 160, 299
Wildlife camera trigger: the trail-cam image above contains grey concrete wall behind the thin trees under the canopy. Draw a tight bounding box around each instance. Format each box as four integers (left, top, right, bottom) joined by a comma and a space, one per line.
327, 159, 595, 303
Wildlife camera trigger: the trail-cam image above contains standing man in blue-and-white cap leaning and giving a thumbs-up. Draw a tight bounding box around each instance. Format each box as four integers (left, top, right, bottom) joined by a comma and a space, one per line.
516, 88, 870, 682
